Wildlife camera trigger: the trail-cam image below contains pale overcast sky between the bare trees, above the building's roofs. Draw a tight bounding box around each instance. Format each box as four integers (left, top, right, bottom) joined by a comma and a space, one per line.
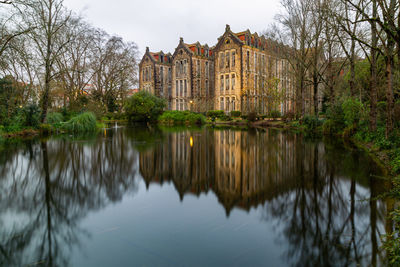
64, 0, 279, 57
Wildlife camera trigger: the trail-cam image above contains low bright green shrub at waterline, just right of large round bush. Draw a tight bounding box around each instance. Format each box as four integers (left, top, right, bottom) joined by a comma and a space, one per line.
158, 110, 206, 125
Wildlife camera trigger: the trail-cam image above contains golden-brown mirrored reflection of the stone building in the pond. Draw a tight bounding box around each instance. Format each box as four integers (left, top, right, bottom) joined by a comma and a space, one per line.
139, 129, 310, 215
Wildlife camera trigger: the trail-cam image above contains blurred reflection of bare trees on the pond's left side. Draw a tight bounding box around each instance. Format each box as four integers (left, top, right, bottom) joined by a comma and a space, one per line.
0, 131, 137, 266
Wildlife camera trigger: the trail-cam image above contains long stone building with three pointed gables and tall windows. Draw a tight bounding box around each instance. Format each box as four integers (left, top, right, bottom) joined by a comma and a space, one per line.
139, 25, 294, 114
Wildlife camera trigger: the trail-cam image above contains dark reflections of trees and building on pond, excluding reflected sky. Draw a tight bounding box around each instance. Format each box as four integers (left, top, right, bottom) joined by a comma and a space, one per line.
0, 127, 392, 266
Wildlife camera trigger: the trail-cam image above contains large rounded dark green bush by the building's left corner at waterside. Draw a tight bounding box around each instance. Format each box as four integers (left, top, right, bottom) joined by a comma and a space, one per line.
124, 91, 166, 122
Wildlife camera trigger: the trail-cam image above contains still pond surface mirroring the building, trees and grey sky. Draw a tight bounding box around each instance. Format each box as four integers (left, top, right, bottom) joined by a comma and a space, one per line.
0, 127, 393, 267
